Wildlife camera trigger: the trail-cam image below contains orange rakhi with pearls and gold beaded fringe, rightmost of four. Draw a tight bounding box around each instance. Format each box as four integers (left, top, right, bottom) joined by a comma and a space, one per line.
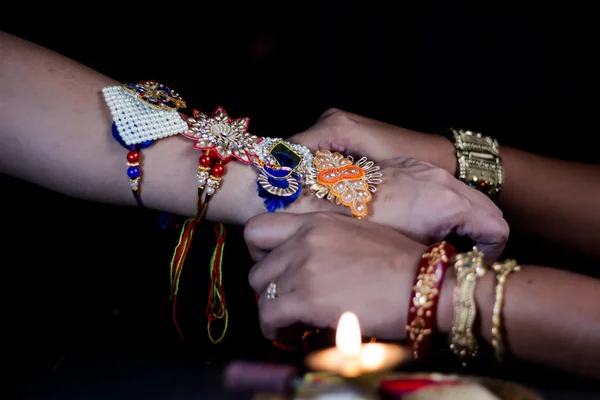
306, 150, 383, 218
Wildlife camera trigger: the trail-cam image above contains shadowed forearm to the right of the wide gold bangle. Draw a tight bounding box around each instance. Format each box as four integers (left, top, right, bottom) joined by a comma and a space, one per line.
440, 141, 600, 259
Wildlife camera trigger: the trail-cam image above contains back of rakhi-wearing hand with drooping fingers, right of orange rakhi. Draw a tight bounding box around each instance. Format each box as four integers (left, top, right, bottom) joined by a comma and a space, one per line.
370, 157, 509, 262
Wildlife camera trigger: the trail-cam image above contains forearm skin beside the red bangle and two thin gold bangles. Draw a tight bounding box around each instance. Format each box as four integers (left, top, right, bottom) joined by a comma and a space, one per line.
437, 265, 600, 379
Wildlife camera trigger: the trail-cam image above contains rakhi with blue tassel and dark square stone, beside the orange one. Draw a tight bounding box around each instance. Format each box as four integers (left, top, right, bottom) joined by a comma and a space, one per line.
254, 138, 313, 212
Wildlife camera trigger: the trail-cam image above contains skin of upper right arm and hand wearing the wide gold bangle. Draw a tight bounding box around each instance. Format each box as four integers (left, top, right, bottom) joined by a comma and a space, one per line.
299, 109, 600, 259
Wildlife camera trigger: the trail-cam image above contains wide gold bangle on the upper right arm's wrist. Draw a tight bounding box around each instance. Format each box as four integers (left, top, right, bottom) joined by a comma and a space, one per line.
452, 129, 504, 199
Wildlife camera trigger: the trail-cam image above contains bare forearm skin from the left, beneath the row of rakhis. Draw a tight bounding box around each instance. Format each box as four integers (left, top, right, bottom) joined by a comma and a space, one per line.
0, 32, 327, 224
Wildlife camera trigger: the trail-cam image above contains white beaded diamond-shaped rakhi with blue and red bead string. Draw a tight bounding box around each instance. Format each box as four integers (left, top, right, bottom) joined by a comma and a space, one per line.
102, 81, 187, 207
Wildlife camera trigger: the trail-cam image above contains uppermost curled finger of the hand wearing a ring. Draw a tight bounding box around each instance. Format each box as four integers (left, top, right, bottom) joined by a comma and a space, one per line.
244, 213, 303, 261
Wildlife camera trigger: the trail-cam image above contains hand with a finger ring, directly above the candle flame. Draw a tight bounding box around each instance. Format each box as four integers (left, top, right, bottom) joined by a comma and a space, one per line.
245, 213, 426, 340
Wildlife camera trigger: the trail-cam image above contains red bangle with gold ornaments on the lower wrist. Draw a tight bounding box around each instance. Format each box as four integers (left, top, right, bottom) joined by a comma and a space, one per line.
406, 242, 456, 360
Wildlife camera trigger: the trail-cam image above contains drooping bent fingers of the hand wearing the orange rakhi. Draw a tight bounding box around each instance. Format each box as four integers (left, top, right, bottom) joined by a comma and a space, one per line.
454, 206, 510, 262
